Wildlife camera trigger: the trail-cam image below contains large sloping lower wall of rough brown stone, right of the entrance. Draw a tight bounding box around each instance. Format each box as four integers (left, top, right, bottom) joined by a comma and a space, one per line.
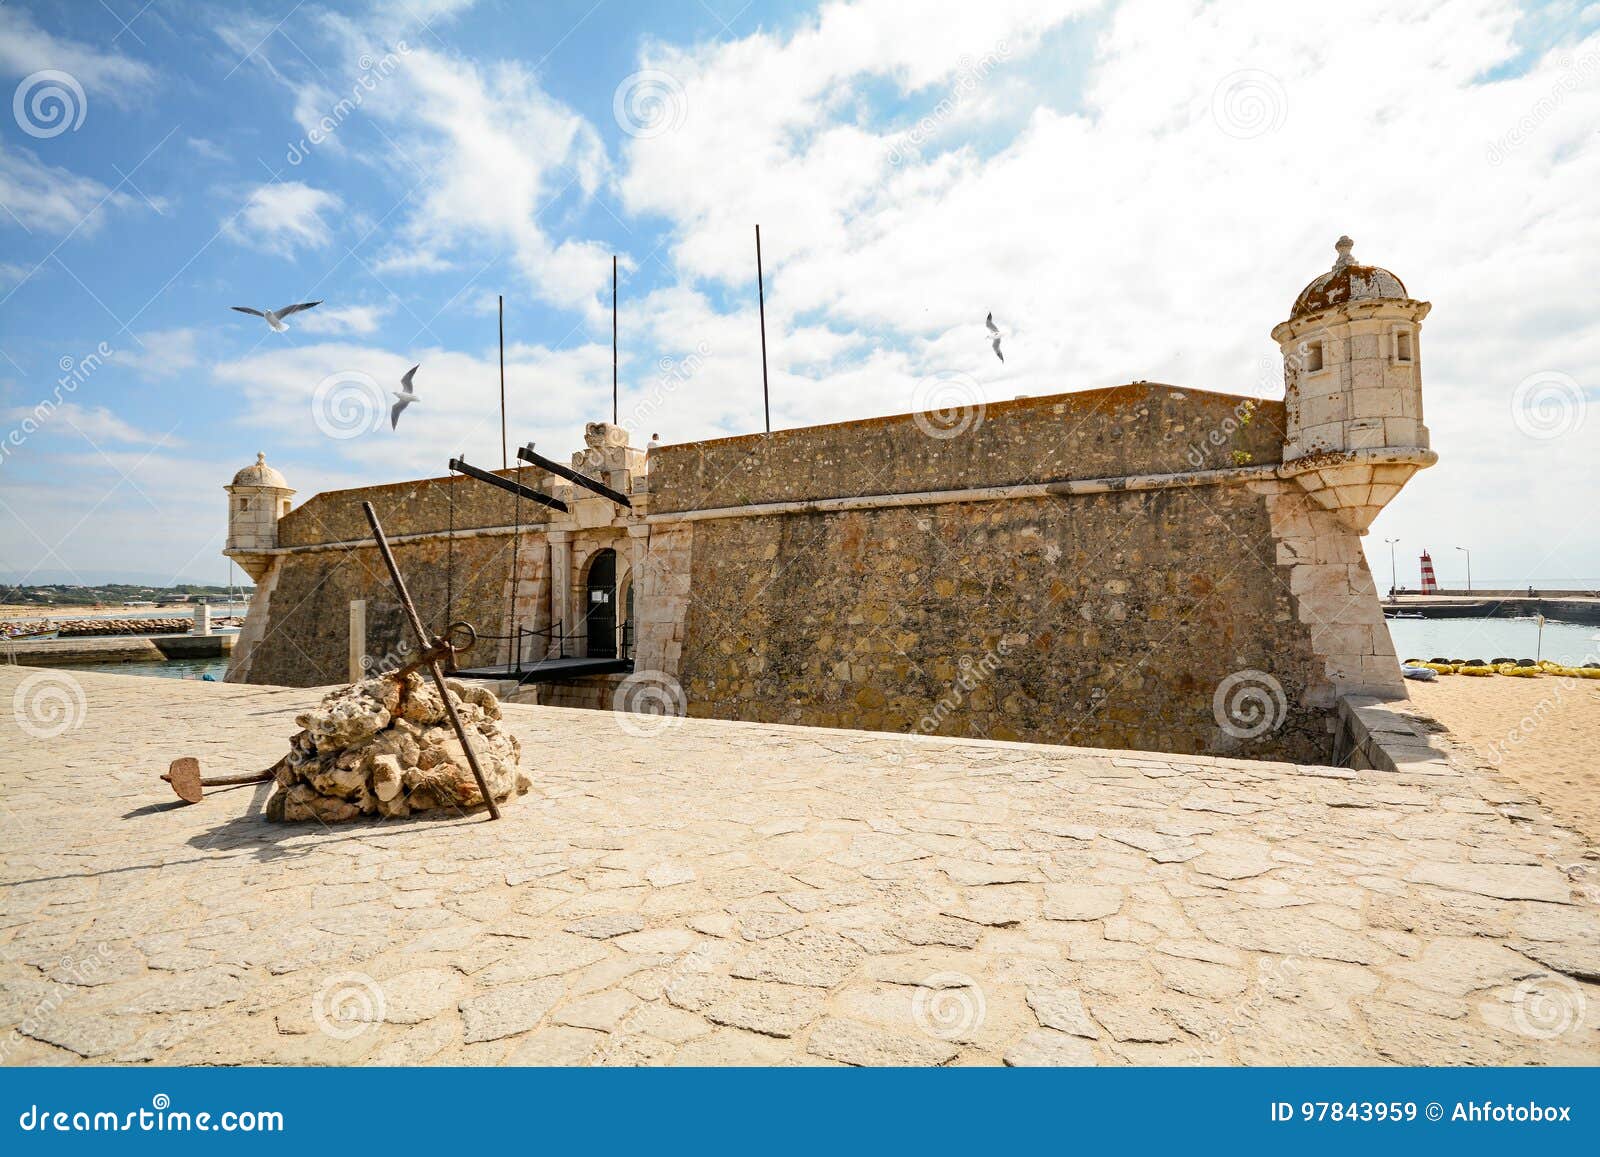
668, 483, 1344, 762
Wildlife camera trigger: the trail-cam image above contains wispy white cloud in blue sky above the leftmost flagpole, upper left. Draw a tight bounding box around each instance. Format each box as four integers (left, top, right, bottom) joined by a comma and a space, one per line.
216, 0, 611, 312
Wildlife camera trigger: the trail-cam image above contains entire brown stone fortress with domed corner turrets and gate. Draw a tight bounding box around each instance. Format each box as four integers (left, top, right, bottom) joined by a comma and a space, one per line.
226, 238, 1435, 763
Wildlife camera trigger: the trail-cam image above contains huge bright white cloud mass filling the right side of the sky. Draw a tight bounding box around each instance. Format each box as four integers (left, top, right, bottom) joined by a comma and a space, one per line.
601, 0, 1600, 588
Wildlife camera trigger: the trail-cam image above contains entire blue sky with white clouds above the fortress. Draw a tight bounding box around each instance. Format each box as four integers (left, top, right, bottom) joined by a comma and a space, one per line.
0, 0, 1600, 584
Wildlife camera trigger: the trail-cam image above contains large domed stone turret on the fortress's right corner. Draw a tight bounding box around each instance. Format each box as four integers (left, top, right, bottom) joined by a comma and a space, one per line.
1272, 237, 1438, 534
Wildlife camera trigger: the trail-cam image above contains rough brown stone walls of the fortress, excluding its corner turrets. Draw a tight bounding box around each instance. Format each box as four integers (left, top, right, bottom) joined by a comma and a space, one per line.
230, 384, 1403, 762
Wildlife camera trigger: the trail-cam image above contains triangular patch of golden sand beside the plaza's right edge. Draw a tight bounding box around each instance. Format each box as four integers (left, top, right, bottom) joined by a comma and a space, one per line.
1406, 675, 1600, 843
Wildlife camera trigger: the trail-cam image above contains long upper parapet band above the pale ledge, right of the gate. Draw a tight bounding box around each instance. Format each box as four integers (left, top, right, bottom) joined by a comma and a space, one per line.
650, 382, 1285, 514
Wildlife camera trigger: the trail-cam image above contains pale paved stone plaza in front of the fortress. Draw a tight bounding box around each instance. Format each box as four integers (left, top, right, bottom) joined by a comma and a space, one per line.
0, 667, 1600, 1064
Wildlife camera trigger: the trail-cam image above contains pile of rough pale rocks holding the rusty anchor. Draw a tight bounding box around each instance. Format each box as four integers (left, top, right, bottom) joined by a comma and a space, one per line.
267, 671, 533, 823
